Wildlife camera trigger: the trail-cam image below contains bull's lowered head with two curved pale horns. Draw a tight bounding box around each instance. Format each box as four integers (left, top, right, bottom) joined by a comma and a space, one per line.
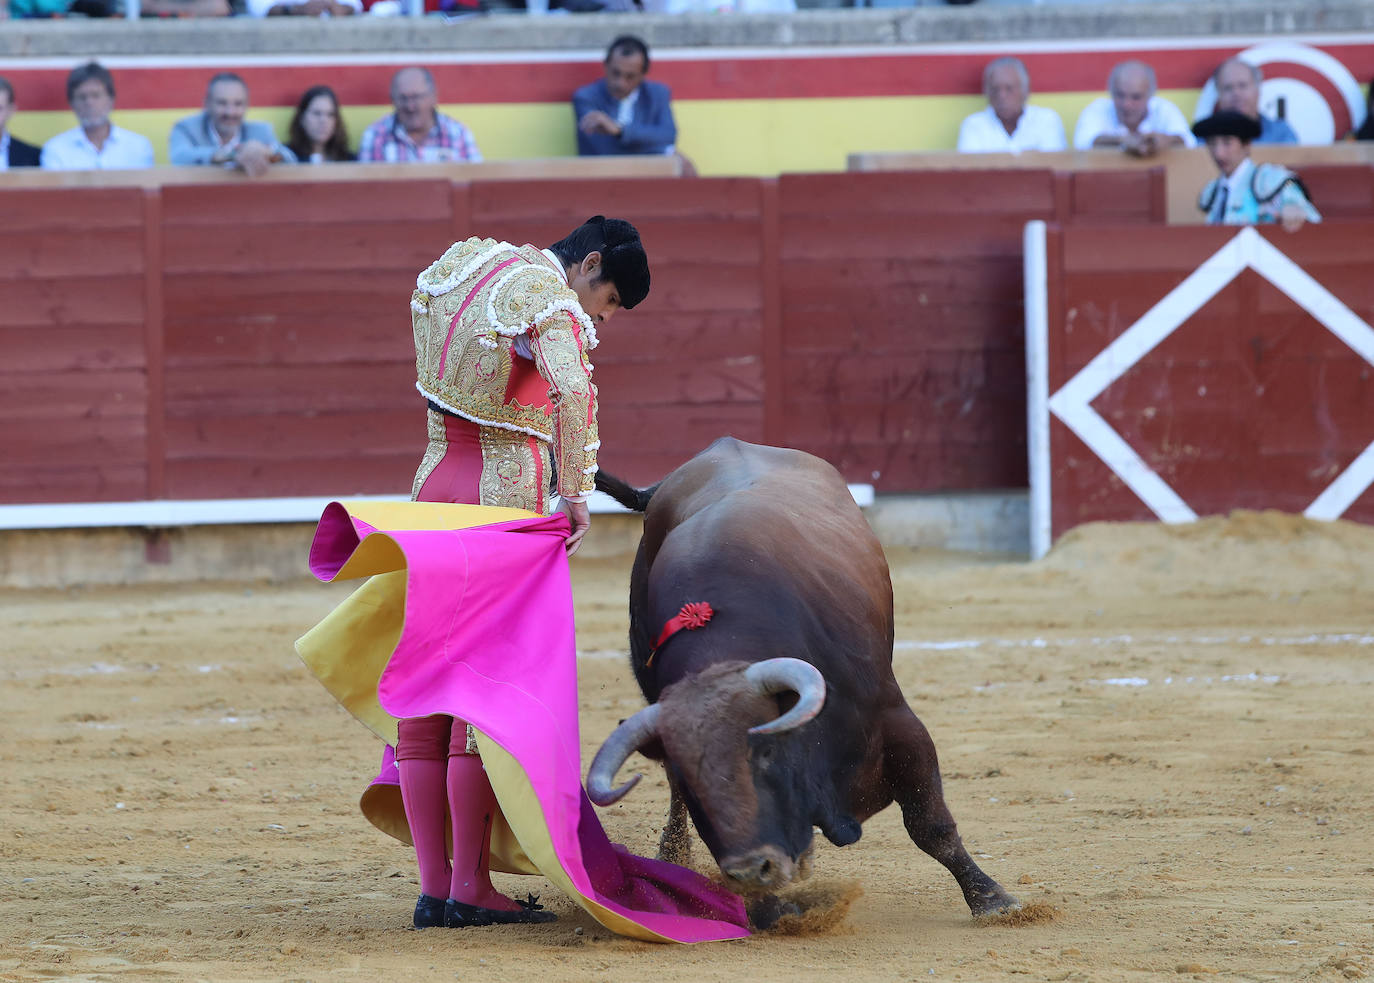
587, 659, 826, 890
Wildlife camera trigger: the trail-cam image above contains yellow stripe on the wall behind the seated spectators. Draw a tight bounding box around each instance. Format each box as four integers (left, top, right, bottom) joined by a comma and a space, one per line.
10, 89, 1200, 176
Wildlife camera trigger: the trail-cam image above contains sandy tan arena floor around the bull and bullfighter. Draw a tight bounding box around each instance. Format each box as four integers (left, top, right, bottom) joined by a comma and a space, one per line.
0, 514, 1374, 983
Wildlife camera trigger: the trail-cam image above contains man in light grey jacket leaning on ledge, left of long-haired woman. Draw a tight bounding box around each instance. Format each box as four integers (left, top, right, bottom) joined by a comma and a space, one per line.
168, 71, 295, 177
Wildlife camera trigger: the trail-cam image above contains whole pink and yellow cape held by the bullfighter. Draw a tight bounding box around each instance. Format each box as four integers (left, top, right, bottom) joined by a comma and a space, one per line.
295, 502, 749, 942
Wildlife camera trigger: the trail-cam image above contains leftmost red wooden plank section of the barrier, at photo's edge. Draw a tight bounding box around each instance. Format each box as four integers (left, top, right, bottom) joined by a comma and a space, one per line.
0, 188, 148, 503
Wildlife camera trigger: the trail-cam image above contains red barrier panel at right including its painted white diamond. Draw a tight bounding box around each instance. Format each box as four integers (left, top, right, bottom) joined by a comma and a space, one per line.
1032, 223, 1374, 546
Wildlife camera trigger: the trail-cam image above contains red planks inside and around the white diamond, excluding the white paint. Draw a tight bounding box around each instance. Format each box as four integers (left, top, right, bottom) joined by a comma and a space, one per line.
1050, 223, 1374, 535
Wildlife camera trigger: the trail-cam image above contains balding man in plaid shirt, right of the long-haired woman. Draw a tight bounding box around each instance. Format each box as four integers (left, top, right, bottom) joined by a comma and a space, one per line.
357, 66, 482, 164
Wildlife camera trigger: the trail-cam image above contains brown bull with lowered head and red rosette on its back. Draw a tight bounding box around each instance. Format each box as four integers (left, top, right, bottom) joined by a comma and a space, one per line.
587, 437, 1020, 916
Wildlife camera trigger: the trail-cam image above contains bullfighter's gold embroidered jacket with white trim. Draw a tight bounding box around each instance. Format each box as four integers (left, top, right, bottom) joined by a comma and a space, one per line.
411, 238, 600, 495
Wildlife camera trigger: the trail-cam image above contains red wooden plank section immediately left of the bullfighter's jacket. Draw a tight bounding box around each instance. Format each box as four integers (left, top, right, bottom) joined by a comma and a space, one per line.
162, 180, 453, 498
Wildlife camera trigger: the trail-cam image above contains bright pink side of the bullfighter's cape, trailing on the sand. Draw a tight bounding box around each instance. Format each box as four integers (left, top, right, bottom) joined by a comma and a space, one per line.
311, 502, 749, 942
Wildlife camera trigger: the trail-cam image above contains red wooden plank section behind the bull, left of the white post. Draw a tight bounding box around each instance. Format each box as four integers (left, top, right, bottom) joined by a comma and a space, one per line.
779, 170, 1055, 491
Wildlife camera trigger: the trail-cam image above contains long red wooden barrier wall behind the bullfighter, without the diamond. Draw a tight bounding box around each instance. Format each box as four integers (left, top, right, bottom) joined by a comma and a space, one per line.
0, 169, 1341, 514
